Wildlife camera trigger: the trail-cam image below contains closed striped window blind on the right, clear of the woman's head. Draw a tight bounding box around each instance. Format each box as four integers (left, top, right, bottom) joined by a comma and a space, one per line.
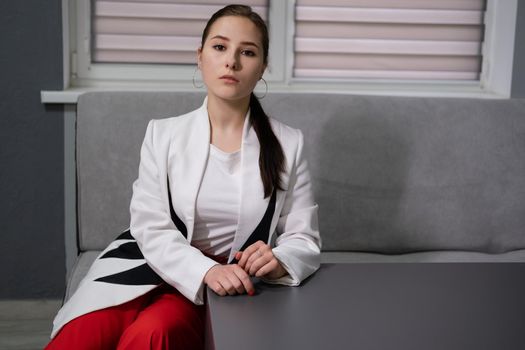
293, 0, 486, 80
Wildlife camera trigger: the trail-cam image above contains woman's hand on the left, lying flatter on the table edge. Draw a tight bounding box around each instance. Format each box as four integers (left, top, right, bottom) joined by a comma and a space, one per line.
204, 264, 255, 296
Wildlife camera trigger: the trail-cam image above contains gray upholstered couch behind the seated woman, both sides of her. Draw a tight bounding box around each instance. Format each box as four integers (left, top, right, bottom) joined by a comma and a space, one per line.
66, 92, 525, 298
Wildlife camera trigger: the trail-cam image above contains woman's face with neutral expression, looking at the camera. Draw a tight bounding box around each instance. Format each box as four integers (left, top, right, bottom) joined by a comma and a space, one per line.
197, 16, 266, 100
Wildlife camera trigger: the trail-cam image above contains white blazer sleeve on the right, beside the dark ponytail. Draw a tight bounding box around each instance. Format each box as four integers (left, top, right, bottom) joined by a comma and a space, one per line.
265, 130, 321, 286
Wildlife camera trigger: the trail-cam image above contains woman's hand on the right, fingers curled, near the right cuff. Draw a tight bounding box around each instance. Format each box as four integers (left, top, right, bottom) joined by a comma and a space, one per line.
235, 241, 287, 279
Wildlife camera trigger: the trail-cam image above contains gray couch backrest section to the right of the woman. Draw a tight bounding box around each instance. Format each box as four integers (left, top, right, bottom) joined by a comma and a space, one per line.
265, 95, 525, 253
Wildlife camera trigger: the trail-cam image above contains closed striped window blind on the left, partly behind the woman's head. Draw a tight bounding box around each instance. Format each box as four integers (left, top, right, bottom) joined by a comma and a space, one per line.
91, 0, 268, 64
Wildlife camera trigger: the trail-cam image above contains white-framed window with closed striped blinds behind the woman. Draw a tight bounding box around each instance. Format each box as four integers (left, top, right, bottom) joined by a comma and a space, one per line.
63, 0, 517, 96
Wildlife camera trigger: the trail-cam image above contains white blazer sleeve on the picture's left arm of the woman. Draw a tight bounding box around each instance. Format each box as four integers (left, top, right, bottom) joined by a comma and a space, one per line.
130, 120, 217, 304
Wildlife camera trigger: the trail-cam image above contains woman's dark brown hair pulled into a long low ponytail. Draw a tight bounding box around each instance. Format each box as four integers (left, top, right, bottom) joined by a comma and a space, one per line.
201, 5, 285, 198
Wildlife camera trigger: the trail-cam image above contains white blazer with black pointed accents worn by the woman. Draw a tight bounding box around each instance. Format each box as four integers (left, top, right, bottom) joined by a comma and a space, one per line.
51, 100, 321, 337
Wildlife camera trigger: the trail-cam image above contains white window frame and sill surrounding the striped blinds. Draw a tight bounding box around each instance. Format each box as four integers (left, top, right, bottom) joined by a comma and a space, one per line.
47, 0, 518, 102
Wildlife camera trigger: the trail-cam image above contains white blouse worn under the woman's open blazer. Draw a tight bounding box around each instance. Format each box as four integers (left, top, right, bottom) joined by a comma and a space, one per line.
191, 144, 241, 256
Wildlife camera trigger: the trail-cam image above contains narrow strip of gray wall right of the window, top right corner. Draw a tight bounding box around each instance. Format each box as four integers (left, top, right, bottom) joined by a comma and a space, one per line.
511, 1, 525, 98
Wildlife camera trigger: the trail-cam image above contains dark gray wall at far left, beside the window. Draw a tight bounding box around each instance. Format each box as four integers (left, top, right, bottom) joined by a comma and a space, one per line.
0, 0, 65, 299
